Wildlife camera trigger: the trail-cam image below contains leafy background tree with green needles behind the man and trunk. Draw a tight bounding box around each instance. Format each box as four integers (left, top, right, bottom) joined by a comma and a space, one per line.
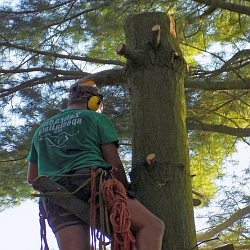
0, 0, 250, 248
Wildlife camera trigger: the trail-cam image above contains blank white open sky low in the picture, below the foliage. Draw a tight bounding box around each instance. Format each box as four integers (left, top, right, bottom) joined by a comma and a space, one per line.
0, 144, 250, 250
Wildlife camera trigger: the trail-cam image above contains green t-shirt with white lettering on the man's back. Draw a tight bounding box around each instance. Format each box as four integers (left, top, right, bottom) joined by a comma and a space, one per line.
27, 109, 118, 180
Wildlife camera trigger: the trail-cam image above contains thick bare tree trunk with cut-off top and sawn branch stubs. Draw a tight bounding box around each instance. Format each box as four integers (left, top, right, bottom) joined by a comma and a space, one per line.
123, 13, 197, 250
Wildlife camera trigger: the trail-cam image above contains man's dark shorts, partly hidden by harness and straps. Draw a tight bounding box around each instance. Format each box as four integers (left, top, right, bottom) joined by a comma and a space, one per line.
39, 168, 99, 233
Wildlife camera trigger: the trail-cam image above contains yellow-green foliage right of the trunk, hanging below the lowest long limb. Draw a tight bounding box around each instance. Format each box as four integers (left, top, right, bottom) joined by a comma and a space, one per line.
189, 131, 235, 206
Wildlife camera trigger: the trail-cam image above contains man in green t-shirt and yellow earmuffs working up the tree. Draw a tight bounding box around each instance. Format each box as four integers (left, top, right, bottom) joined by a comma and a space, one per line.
27, 83, 165, 250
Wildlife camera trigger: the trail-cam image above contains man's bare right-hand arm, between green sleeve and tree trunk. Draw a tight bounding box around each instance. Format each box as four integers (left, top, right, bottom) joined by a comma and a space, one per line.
101, 142, 128, 188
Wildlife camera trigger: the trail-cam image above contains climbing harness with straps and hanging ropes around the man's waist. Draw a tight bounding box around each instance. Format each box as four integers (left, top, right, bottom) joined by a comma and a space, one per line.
33, 167, 135, 250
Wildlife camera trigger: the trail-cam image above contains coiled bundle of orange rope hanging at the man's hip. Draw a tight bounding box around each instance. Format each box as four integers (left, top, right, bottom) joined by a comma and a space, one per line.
102, 178, 135, 250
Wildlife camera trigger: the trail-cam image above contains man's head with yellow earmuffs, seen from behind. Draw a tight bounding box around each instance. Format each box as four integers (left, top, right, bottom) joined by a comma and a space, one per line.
68, 82, 102, 111
